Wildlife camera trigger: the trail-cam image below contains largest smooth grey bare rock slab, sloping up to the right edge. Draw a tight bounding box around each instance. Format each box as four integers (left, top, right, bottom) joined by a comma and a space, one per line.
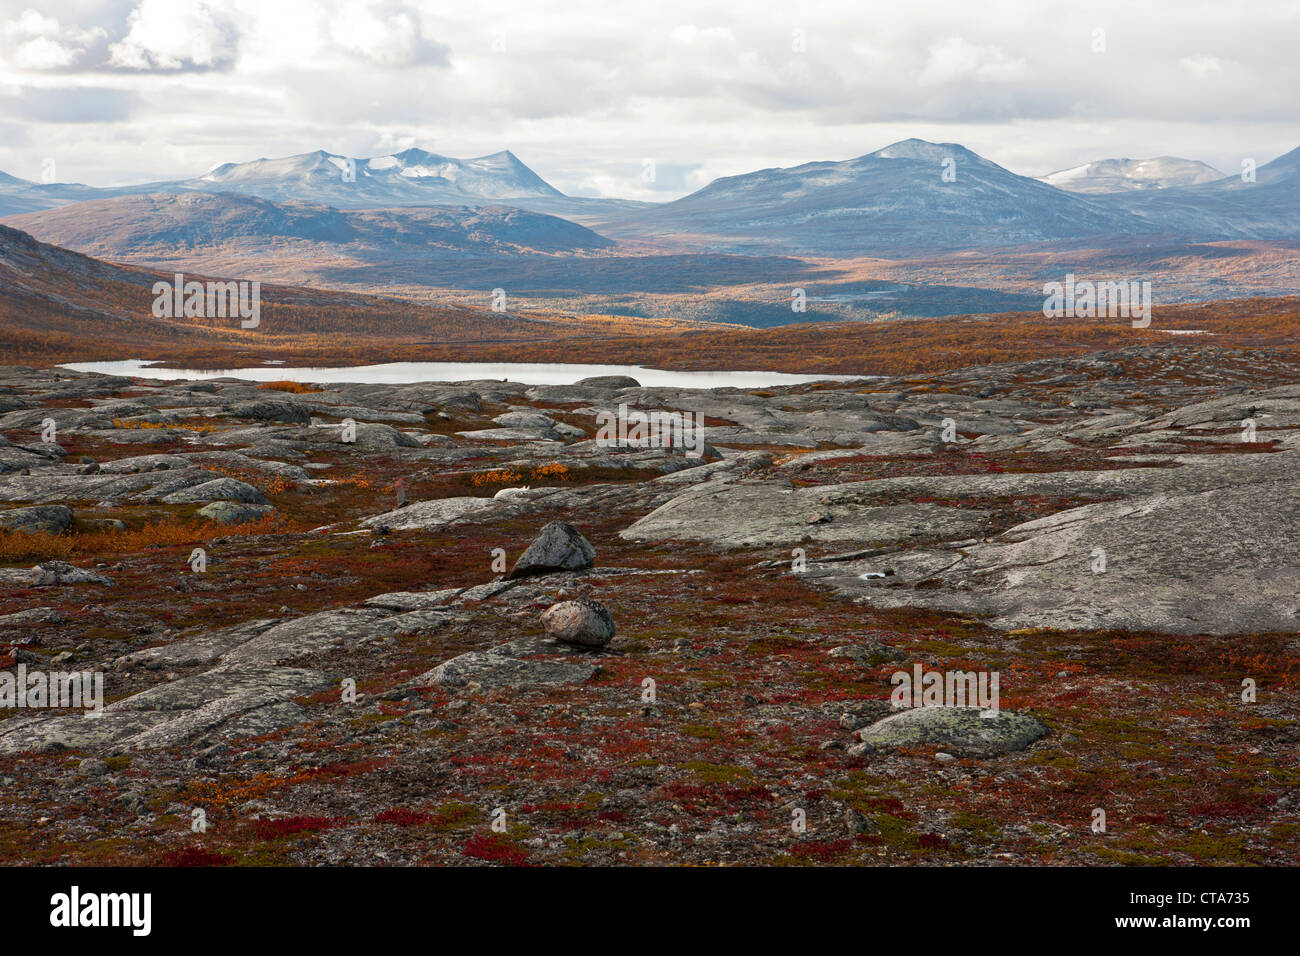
842, 478, 1300, 635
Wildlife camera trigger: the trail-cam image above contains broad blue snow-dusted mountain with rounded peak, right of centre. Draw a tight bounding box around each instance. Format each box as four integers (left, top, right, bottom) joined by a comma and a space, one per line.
598, 139, 1143, 255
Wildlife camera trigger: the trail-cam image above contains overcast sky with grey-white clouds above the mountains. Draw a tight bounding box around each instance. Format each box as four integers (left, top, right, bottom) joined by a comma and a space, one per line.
0, 0, 1300, 199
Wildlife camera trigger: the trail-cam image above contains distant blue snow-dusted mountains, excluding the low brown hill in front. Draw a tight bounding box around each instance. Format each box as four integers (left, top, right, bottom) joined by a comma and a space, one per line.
0, 139, 1300, 256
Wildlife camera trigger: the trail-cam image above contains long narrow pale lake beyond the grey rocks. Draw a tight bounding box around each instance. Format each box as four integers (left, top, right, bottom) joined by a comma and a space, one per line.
61, 359, 871, 389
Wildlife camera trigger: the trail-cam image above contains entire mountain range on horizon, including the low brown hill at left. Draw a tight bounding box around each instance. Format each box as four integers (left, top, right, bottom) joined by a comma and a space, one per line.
0, 139, 1300, 264
